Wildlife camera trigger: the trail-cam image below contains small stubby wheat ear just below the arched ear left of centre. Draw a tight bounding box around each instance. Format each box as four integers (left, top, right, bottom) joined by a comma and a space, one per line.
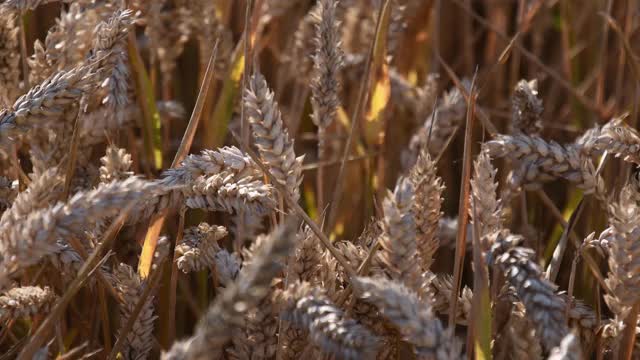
175, 223, 228, 274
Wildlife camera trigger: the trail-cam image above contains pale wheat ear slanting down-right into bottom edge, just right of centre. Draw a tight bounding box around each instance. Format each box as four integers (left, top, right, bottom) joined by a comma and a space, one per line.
353, 277, 462, 359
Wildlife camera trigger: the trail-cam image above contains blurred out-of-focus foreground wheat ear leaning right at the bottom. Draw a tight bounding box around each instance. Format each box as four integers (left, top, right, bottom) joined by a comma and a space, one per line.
163, 224, 295, 359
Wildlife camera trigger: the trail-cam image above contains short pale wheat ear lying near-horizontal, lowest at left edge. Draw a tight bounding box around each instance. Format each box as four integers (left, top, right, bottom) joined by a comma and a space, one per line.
0, 286, 57, 321
